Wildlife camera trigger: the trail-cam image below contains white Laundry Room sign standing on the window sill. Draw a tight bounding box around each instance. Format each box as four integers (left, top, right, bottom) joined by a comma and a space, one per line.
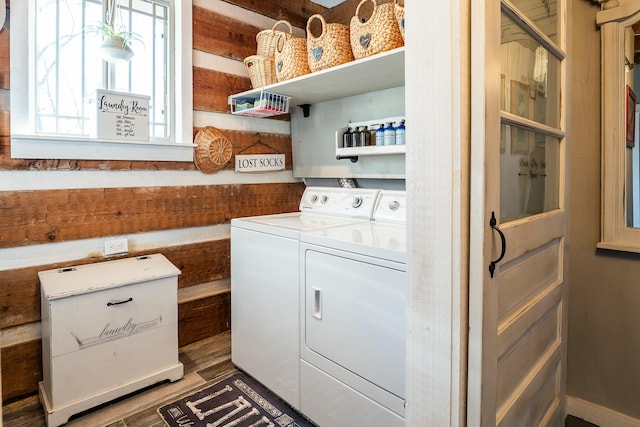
96, 89, 149, 141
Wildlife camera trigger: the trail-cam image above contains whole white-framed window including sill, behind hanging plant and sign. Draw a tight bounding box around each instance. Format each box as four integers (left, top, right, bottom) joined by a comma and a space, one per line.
11, 0, 193, 160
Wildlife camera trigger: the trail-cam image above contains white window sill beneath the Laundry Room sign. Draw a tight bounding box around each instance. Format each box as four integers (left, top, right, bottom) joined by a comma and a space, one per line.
11, 135, 195, 162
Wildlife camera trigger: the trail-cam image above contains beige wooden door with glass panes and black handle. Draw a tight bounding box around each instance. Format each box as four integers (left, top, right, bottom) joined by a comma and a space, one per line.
467, 0, 567, 426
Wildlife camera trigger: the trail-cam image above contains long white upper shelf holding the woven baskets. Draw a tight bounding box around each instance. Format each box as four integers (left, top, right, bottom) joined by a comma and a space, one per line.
229, 47, 404, 109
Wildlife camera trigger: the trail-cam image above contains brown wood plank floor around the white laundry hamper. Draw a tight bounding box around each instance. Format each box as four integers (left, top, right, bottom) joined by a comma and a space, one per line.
2, 332, 237, 427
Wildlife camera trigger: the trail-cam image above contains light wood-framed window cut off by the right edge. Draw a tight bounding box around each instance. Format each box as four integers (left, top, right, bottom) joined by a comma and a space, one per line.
596, 3, 640, 253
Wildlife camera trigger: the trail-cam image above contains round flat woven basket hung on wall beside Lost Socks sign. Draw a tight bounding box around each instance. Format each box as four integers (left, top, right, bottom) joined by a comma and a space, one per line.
193, 126, 233, 173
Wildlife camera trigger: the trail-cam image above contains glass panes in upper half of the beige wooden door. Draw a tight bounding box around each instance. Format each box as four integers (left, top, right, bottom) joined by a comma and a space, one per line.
500, 5, 566, 223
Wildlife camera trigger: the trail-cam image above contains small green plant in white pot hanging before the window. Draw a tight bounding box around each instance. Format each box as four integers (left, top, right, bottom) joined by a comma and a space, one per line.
85, 0, 143, 62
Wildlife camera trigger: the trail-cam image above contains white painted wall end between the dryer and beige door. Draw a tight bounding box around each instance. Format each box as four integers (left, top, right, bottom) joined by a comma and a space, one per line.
405, 0, 470, 427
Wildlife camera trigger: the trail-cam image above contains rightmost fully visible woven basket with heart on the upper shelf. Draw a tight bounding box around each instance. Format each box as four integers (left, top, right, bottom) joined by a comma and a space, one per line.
350, 0, 404, 59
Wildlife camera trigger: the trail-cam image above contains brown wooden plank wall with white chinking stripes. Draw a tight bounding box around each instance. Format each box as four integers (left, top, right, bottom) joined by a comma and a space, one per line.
0, 0, 318, 404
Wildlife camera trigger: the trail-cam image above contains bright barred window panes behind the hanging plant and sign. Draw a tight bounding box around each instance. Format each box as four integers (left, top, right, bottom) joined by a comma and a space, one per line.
34, 0, 173, 140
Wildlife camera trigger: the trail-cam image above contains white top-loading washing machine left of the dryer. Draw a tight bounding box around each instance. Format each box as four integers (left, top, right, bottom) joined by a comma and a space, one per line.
231, 187, 379, 409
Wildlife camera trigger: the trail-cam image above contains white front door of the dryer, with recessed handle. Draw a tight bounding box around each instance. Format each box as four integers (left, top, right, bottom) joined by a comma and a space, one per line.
303, 246, 406, 397
